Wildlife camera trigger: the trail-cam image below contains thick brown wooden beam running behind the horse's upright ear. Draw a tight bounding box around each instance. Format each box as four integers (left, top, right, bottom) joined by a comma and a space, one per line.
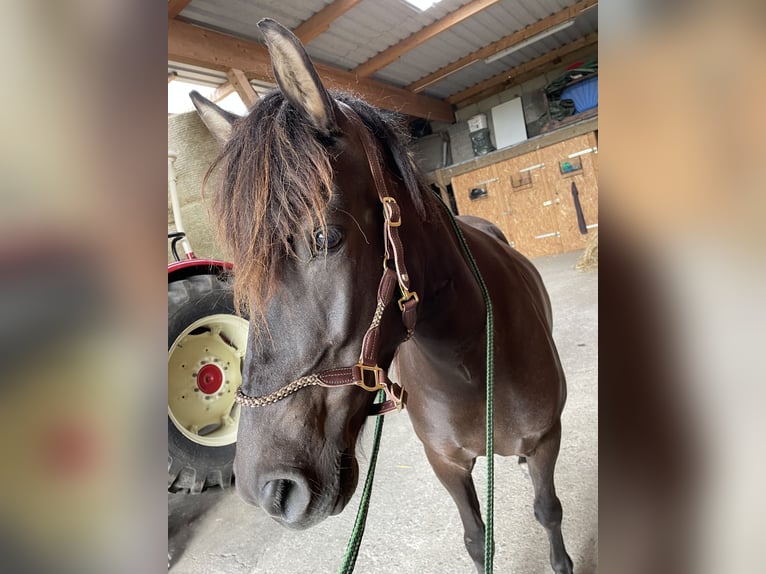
168, 20, 455, 122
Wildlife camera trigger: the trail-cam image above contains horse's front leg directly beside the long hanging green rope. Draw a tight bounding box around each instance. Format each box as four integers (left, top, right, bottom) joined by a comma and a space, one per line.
426, 448, 484, 574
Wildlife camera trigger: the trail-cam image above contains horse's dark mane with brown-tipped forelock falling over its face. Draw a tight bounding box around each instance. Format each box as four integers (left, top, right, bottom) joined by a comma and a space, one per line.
205, 90, 428, 319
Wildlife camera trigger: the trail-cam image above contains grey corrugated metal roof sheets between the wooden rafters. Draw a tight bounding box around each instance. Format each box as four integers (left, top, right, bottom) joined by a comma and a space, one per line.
174, 0, 598, 108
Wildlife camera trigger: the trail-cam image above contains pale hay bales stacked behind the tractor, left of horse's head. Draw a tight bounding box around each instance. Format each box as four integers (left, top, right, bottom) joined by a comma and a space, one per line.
168, 112, 225, 261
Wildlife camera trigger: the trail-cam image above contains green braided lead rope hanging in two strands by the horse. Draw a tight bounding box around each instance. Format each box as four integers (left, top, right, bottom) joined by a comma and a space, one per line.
340, 198, 495, 574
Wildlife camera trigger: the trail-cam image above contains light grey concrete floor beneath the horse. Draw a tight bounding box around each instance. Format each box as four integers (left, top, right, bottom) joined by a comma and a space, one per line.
168, 252, 598, 574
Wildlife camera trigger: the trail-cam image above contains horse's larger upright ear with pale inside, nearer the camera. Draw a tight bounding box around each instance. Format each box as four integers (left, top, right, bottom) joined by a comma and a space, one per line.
258, 18, 335, 134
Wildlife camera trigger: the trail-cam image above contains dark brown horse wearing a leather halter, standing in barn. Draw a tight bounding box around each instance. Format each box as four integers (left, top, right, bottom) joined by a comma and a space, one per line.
192, 19, 572, 574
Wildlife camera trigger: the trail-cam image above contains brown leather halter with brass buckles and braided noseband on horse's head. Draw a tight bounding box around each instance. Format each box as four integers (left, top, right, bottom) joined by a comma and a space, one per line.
235, 102, 420, 416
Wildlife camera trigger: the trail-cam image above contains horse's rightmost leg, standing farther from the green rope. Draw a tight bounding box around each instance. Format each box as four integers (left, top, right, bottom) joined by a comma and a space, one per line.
527, 422, 573, 574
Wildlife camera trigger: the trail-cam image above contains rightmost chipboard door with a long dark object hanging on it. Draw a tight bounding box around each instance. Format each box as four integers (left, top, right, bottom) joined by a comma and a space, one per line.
538, 134, 598, 251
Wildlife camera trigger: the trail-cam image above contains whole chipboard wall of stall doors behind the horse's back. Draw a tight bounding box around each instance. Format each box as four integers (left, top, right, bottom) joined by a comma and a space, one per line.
452, 132, 598, 257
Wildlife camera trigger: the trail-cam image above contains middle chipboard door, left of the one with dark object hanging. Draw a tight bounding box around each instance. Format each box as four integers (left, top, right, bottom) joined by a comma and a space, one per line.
496, 151, 563, 257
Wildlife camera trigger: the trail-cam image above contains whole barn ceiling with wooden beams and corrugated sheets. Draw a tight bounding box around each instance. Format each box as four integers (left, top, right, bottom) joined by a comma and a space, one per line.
168, 0, 598, 121
